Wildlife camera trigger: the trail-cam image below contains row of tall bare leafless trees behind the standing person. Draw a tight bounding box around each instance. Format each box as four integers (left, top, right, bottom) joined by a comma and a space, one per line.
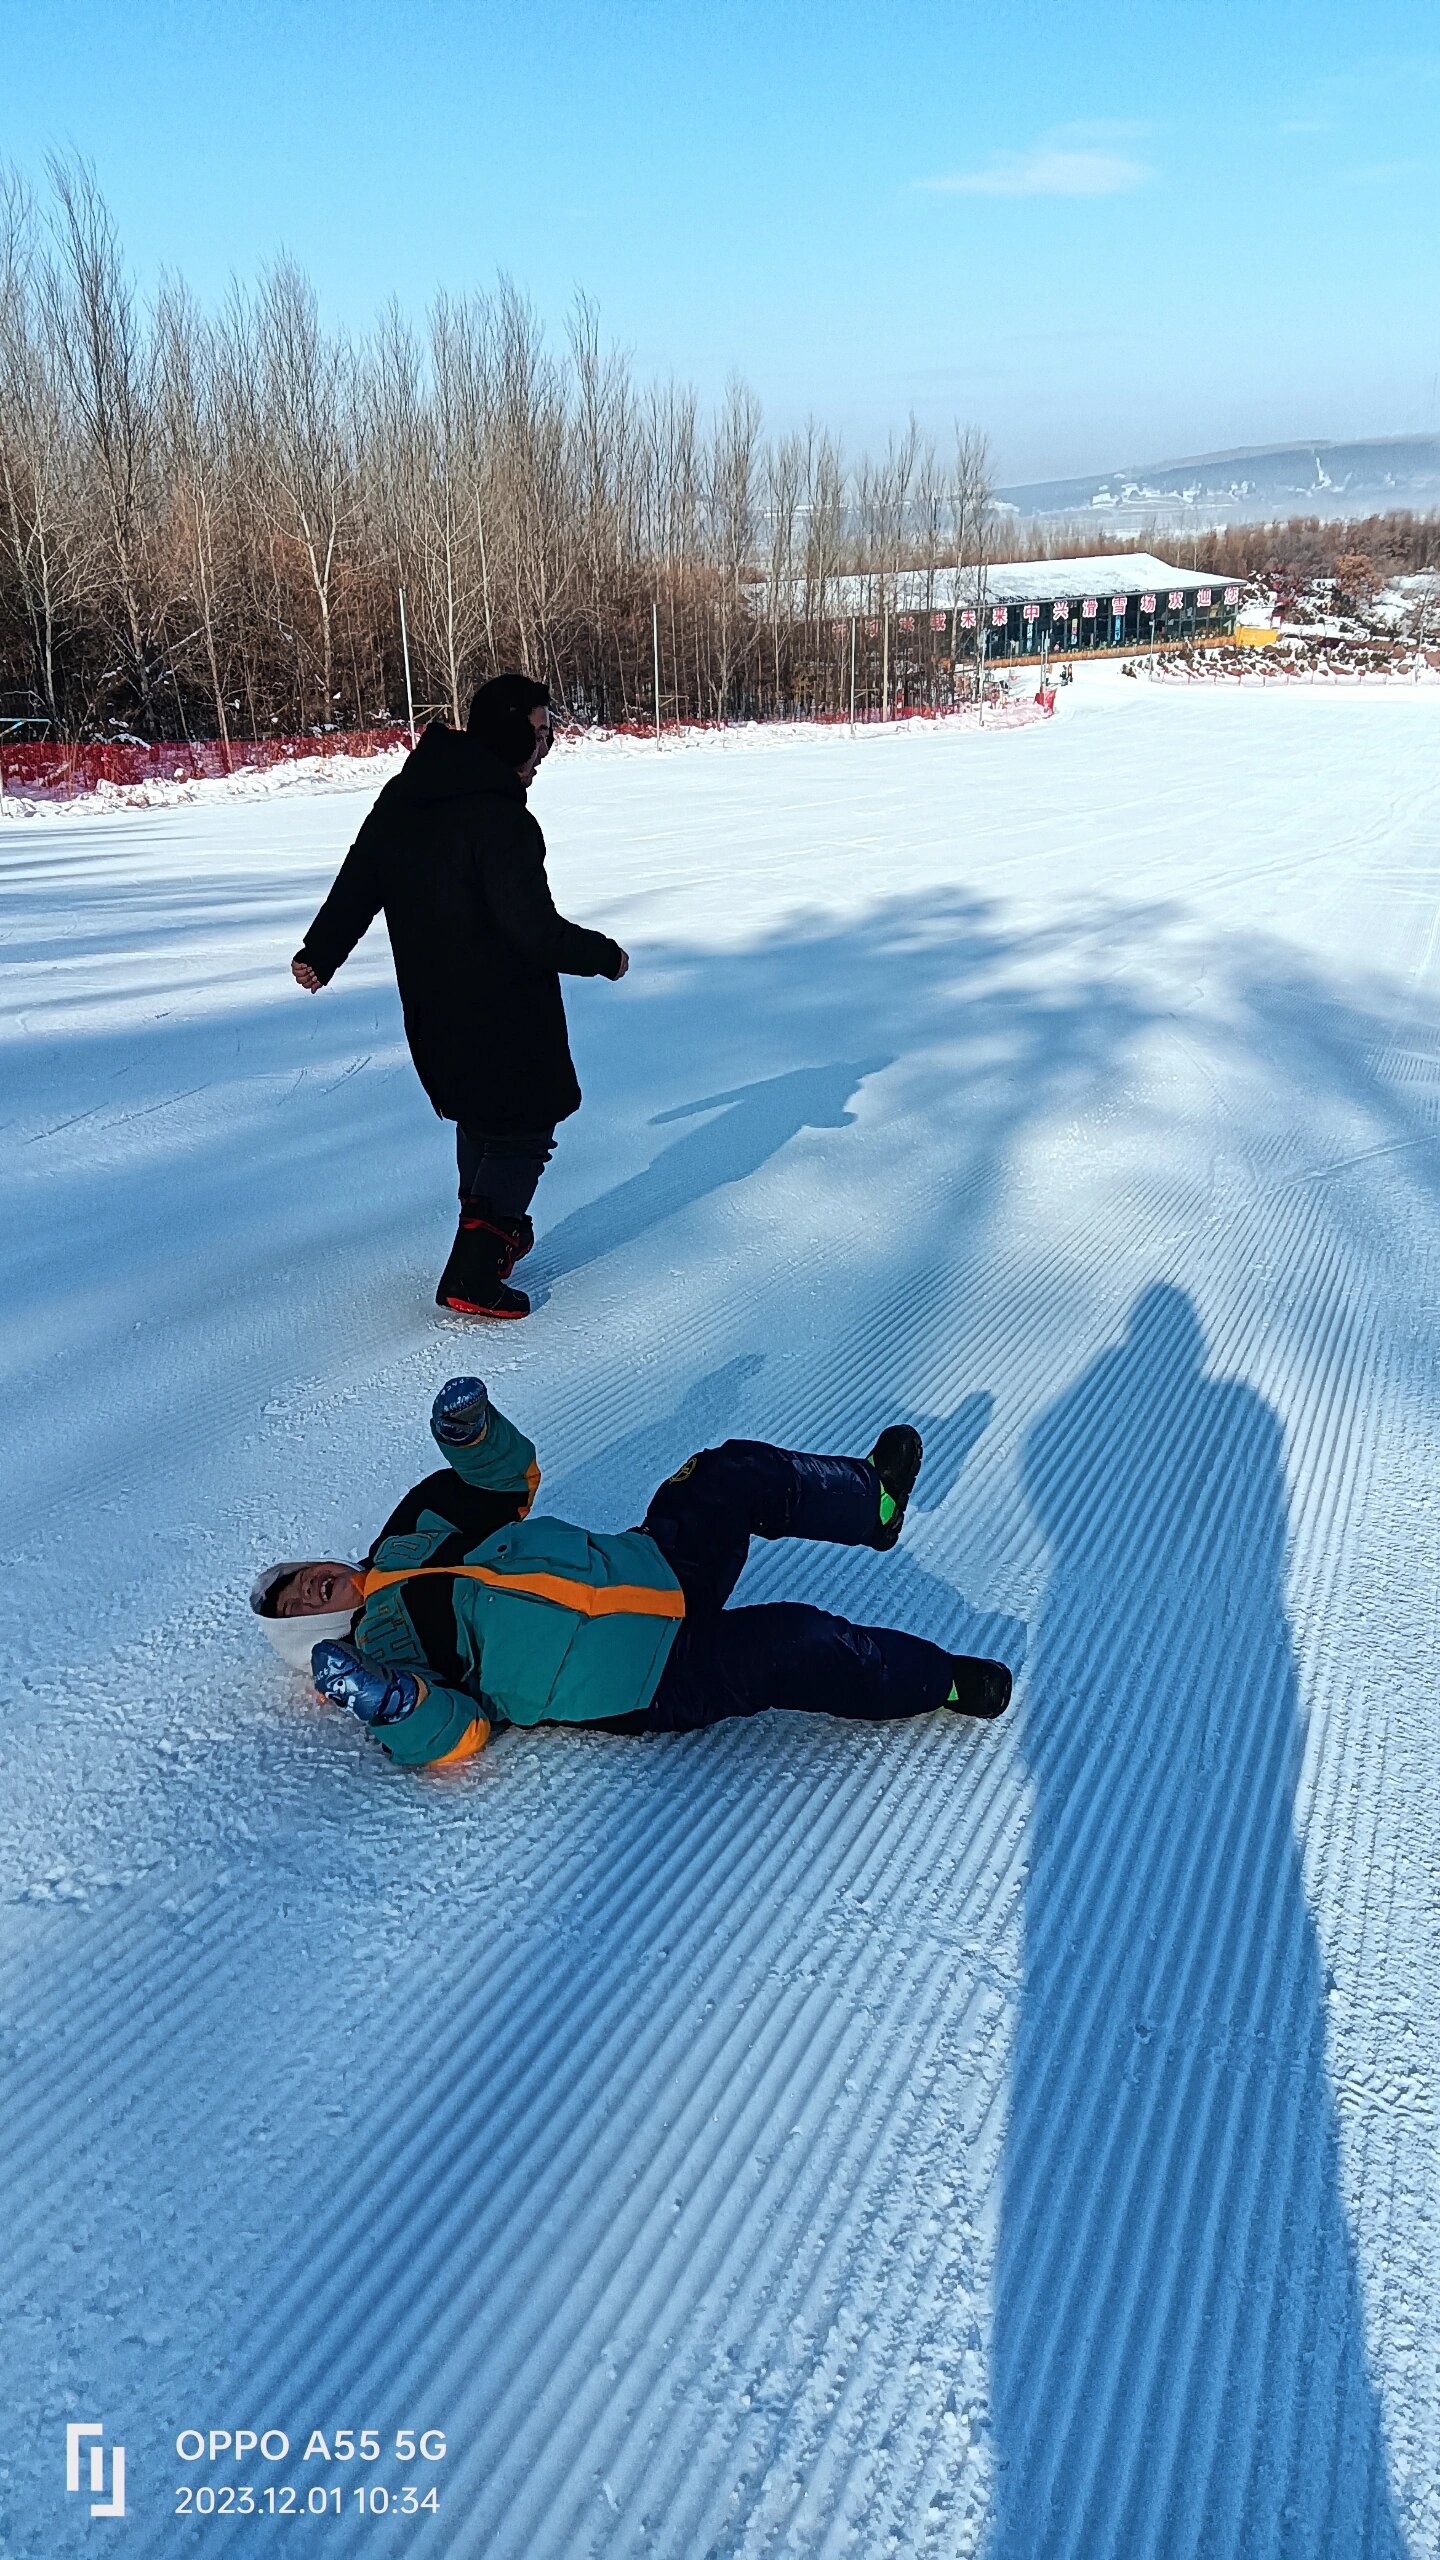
0, 161, 1009, 740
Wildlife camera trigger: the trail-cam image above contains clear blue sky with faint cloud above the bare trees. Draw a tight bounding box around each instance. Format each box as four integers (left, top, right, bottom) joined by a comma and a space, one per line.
0, 0, 1440, 479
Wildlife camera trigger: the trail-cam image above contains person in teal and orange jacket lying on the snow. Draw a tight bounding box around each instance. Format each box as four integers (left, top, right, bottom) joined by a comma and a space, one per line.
251, 1377, 1010, 1766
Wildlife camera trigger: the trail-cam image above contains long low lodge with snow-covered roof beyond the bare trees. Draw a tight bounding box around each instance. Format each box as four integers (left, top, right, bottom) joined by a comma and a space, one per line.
753, 550, 1240, 660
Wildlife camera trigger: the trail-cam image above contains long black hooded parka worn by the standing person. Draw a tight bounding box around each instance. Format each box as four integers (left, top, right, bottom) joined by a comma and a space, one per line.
297, 722, 623, 1137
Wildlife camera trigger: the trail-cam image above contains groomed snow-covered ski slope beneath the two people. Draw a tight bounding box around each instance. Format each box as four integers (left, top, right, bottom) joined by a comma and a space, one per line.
0, 673, 1440, 2560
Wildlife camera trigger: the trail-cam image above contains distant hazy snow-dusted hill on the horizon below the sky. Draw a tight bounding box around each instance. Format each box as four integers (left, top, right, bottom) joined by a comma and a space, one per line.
999, 435, 1440, 532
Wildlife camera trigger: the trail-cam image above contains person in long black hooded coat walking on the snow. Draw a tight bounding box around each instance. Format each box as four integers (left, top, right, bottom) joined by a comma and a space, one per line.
290, 676, 630, 1318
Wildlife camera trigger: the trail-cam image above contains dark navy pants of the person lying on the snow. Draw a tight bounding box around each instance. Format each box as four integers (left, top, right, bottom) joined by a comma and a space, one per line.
591, 1441, 953, 1733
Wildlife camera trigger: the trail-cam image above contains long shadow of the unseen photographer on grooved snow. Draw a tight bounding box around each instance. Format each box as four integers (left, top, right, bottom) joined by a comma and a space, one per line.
989, 1285, 1404, 2560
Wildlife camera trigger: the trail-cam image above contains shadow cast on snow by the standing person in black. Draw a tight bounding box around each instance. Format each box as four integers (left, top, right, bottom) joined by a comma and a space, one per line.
525, 1057, 892, 1285
